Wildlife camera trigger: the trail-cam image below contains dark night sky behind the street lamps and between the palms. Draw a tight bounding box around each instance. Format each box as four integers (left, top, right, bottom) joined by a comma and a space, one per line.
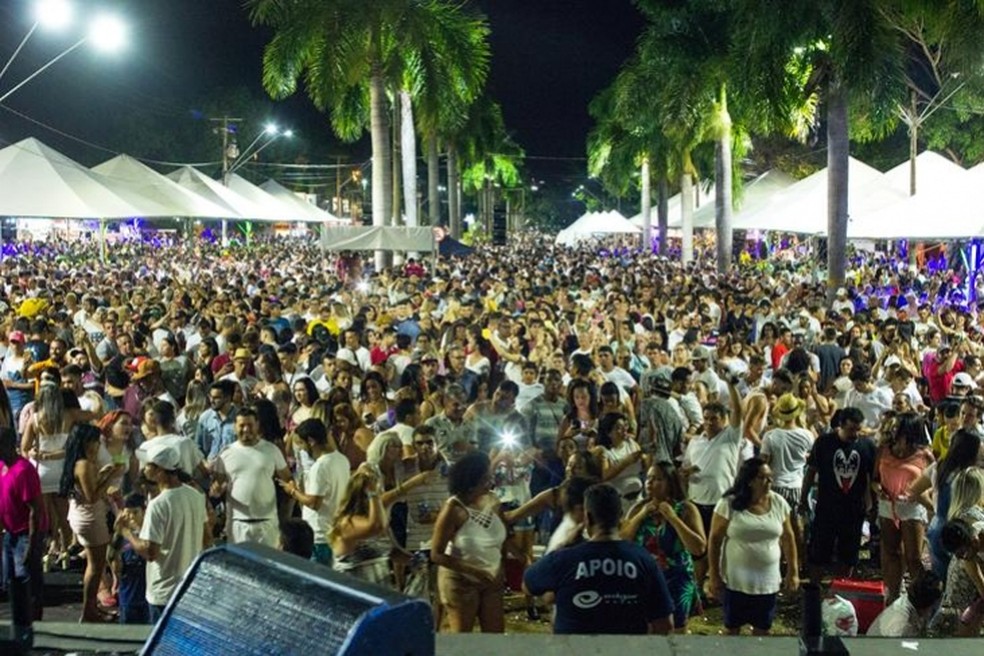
0, 0, 642, 188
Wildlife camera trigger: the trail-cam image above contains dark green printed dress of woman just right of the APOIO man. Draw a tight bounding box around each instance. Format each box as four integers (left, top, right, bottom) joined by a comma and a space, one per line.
635, 501, 703, 629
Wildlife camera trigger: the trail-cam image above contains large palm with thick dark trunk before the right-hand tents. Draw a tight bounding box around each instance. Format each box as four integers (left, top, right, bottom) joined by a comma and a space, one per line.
732, 0, 902, 297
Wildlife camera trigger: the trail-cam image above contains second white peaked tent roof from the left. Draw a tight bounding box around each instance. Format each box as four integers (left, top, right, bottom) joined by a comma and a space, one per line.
92, 155, 240, 219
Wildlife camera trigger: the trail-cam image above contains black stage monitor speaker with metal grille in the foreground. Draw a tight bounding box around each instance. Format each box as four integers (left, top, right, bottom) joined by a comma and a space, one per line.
141, 544, 434, 656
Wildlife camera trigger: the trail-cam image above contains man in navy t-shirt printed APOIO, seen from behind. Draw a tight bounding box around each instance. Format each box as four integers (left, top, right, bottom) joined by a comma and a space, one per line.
523, 484, 673, 635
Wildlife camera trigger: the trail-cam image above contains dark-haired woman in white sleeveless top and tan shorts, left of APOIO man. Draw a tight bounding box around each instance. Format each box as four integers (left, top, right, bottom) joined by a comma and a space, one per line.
431, 451, 535, 633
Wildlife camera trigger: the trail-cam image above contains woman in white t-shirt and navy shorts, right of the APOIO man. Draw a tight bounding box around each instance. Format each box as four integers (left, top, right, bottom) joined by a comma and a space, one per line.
706, 458, 799, 635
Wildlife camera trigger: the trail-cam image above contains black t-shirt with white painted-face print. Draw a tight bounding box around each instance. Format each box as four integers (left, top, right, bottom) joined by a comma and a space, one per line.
807, 433, 875, 518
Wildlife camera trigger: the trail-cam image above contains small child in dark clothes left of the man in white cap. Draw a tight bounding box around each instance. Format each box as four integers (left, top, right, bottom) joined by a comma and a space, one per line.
107, 493, 150, 624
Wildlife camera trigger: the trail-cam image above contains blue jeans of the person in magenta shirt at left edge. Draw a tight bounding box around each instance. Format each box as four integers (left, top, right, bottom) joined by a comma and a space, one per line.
3, 533, 44, 645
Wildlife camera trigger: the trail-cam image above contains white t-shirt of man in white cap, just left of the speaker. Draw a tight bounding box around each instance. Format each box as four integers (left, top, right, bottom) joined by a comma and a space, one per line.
140, 485, 206, 606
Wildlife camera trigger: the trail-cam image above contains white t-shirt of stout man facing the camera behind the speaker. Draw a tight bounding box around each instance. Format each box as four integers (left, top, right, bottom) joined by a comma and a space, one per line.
215, 440, 287, 520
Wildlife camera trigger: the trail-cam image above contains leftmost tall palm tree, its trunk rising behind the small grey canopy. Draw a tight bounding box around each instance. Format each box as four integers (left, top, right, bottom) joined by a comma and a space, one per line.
246, 0, 487, 265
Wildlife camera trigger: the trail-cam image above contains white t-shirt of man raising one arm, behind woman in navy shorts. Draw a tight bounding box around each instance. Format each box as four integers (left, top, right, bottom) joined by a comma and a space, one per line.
683, 425, 745, 506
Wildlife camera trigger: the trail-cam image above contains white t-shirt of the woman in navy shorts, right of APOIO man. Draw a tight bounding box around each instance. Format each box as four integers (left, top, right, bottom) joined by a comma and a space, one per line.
714, 492, 789, 595
